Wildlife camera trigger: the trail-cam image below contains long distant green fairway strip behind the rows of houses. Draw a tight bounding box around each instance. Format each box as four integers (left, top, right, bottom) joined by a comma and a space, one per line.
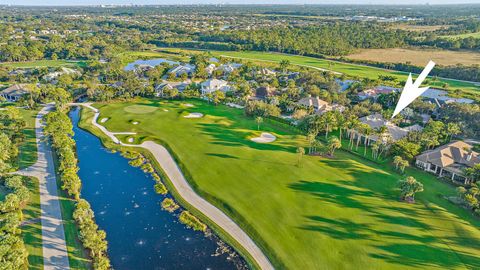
158, 48, 480, 99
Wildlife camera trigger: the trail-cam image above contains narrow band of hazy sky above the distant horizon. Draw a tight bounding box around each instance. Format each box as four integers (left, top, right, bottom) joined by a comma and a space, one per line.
0, 0, 480, 6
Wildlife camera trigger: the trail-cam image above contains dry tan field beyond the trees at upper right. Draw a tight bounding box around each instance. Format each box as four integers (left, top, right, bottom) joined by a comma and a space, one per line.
346, 48, 480, 66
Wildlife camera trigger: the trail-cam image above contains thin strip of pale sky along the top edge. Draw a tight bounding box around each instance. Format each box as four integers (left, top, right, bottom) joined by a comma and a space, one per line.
0, 0, 480, 5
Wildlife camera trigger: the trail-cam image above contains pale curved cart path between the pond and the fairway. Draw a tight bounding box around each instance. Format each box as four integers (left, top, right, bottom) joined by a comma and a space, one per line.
71, 103, 274, 270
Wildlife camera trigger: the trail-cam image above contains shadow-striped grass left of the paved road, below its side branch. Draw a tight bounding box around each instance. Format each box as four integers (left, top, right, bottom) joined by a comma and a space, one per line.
21, 177, 43, 270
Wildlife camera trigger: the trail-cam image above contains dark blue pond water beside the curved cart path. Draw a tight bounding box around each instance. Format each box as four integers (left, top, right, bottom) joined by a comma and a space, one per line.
70, 108, 245, 270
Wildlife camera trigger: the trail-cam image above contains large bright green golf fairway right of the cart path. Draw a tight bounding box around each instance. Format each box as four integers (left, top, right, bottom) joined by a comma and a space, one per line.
89, 99, 480, 269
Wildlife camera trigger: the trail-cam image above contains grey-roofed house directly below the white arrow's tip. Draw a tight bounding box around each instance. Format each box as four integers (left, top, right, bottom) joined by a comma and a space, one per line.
356, 113, 423, 144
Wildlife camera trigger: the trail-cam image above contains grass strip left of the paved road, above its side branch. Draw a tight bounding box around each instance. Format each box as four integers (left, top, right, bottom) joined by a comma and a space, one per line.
17, 109, 38, 169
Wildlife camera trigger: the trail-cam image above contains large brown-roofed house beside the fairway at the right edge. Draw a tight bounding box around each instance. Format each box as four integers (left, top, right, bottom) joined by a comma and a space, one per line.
415, 141, 480, 184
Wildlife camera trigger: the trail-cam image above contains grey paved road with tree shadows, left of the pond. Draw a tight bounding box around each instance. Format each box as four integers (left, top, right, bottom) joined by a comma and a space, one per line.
18, 105, 70, 270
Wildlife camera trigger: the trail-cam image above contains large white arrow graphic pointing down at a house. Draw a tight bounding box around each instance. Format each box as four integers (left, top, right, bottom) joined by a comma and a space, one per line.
392, 61, 435, 118
